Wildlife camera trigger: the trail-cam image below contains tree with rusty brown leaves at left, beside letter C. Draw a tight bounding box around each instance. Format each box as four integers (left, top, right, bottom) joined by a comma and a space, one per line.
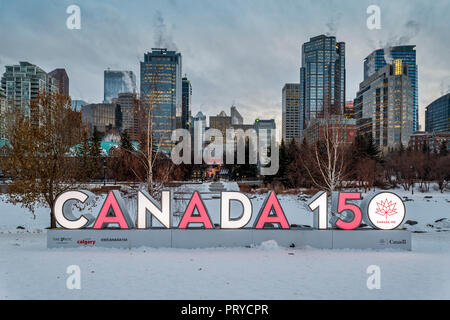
2, 92, 83, 228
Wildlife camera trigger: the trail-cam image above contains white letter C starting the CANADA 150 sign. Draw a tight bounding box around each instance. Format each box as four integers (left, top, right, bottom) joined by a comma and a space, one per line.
53, 191, 94, 229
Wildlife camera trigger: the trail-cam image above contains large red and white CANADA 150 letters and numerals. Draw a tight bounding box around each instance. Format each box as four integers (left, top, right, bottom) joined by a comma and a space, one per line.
54, 191, 406, 230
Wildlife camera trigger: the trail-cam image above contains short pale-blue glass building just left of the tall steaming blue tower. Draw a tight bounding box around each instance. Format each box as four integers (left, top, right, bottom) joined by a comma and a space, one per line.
103, 69, 136, 103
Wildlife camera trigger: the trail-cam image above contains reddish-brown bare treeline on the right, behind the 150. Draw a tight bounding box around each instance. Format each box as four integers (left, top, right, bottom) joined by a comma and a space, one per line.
264, 135, 450, 192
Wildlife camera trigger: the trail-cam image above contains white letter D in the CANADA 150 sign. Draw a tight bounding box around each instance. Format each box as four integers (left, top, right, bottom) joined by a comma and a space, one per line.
220, 192, 252, 229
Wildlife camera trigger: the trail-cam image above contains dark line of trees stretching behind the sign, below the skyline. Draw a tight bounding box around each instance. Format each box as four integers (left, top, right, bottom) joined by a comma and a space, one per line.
99, 133, 450, 191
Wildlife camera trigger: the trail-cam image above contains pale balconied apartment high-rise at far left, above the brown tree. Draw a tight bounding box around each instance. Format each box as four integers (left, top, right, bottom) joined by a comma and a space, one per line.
1, 62, 58, 117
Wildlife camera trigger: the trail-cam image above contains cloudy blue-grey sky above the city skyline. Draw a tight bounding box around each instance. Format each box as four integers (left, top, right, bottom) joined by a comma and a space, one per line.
0, 0, 450, 127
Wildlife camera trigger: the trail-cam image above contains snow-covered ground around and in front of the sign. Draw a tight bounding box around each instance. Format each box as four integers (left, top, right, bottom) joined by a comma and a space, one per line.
0, 185, 450, 299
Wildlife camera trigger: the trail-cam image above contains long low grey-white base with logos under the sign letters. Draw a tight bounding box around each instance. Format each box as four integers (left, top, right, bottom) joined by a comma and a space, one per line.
47, 228, 412, 250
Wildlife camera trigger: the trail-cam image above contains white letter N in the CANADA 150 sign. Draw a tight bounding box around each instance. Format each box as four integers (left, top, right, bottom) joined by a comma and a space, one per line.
137, 191, 171, 229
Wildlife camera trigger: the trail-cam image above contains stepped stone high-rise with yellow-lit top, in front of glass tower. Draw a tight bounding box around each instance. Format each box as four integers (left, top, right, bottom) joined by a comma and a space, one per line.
354, 59, 414, 151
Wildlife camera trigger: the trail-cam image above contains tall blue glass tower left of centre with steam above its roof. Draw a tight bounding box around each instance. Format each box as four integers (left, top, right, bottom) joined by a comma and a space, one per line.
141, 48, 182, 152
